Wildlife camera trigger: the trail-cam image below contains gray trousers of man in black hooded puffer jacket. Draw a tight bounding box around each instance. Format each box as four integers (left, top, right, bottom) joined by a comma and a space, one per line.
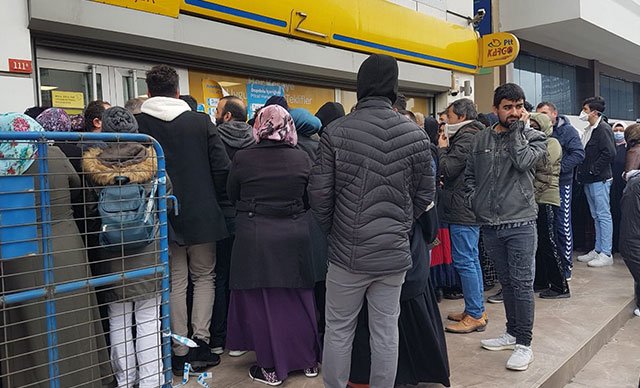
322, 264, 405, 388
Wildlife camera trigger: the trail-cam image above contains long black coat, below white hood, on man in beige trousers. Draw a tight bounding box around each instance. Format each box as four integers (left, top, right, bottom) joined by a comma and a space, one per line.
136, 111, 230, 245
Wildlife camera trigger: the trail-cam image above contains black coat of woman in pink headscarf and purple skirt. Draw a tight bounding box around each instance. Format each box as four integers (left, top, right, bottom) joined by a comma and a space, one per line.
227, 140, 314, 290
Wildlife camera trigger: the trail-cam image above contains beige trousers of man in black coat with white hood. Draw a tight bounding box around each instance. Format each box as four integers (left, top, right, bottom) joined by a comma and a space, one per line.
169, 243, 216, 356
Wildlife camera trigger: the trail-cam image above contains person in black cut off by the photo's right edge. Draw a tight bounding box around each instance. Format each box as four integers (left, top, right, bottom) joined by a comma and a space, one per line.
619, 124, 640, 317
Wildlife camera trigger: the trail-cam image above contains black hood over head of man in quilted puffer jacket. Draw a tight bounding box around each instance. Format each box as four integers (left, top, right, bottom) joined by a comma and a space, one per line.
357, 54, 398, 104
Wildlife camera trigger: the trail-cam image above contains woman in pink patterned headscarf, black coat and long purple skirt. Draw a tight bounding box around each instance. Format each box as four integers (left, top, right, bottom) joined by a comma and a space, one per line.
227, 105, 320, 385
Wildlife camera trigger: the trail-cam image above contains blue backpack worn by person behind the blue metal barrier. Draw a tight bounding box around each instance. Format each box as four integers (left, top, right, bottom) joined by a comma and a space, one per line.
98, 177, 158, 250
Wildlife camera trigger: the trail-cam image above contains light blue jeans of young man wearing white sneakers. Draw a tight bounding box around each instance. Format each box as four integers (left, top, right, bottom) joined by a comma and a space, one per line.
584, 179, 613, 256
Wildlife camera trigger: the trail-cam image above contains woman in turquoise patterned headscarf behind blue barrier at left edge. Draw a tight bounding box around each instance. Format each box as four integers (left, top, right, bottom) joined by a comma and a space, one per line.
0, 113, 113, 387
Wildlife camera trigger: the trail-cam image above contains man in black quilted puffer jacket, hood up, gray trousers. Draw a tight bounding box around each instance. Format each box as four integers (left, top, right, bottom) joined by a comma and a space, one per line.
309, 55, 435, 388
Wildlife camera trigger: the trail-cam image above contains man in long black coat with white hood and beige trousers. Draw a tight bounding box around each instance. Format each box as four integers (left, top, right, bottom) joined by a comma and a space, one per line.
136, 65, 230, 375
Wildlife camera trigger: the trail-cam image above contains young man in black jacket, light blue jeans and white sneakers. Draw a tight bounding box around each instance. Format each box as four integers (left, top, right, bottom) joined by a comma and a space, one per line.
578, 97, 616, 267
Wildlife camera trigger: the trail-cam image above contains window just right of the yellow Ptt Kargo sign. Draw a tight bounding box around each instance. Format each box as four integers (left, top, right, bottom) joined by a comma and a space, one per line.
513, 54, 579, 114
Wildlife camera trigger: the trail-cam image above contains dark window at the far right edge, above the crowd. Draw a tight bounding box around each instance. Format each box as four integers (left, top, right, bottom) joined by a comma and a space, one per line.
600, 74, 640, 120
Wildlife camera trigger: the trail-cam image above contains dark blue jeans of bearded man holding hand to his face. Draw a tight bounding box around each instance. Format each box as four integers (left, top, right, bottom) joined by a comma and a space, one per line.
482, 224, 538, 346
